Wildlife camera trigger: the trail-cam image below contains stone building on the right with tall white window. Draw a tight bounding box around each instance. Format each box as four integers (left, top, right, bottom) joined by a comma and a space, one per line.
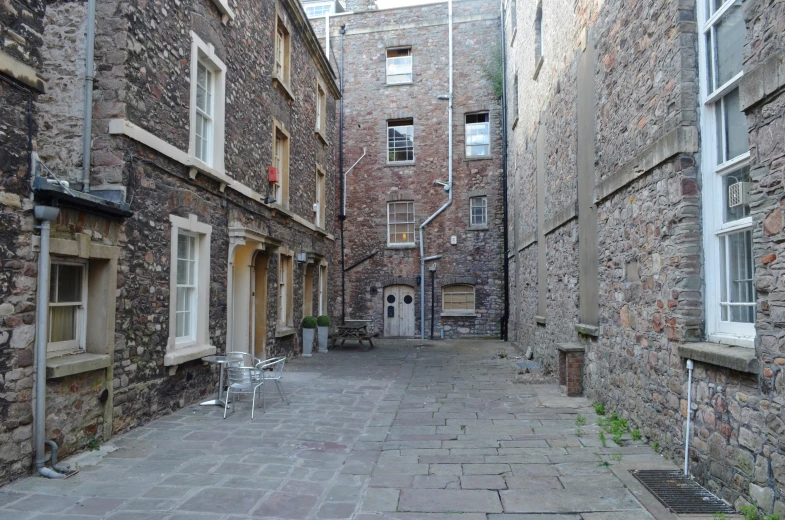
503, 0, 785, 516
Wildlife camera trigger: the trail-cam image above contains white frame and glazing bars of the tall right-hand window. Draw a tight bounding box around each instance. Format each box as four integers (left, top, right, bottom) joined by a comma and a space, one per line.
698, 0, 756, 347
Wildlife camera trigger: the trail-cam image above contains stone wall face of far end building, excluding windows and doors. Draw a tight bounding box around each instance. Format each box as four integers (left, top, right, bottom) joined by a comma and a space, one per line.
311, 0, 503, 338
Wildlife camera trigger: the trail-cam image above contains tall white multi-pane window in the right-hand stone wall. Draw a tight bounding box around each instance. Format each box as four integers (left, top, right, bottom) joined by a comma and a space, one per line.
698, 0, 755, 347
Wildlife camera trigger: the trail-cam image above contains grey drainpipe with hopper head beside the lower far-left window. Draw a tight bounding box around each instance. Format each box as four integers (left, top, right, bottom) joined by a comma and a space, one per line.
34, 206, 65, 478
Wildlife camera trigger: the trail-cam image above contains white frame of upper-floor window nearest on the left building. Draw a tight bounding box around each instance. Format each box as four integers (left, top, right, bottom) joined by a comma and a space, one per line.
188, 31, 226, 174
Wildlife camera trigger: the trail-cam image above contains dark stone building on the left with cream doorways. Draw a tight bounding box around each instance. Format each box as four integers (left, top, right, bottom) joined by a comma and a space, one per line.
0, 0, 340, 484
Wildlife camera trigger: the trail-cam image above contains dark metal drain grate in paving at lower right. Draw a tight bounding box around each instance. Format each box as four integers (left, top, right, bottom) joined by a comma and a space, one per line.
630, 470, 736, 515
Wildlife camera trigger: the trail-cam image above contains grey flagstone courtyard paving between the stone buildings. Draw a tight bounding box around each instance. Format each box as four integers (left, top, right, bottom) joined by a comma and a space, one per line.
0, 341, 716, 520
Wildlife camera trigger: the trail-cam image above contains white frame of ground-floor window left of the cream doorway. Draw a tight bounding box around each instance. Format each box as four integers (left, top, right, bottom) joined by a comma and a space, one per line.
166, 215, 214, 352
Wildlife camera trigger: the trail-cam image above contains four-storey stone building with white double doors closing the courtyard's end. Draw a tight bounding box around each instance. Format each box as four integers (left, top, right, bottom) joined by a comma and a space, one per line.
306, 0, 504, 338
